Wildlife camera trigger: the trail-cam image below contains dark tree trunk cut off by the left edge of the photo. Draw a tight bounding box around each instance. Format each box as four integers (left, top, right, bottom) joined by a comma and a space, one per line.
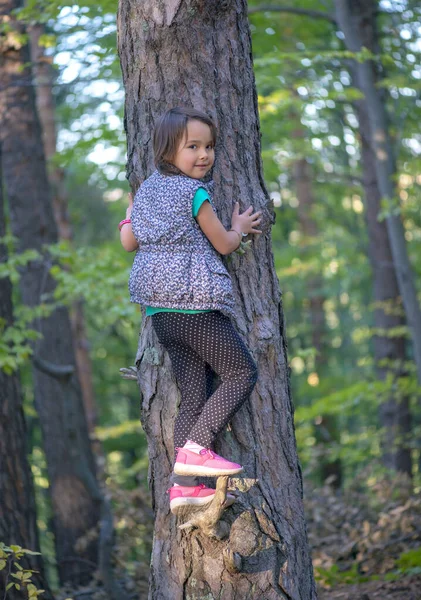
0, 146, 53, 600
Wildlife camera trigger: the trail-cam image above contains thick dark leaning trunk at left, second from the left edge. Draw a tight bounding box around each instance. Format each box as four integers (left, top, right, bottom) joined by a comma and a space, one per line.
0, 0, 101, 584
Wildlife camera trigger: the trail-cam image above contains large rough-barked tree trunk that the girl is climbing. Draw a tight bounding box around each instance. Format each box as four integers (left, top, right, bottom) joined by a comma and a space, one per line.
118, 0, 316, 600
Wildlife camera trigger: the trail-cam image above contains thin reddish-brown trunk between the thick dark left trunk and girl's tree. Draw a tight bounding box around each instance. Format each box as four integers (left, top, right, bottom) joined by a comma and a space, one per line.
29, 24, 98, 434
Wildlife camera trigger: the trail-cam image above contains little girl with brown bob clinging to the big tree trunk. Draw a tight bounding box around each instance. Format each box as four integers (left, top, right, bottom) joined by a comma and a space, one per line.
119, 108, 261, 512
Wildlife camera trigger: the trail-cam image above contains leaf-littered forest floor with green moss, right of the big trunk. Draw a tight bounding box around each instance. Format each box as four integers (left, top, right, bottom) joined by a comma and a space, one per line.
304, 474, 421, 600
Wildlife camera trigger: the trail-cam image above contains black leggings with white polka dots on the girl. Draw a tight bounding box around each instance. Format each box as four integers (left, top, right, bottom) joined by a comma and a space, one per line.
152, 311, 257, 448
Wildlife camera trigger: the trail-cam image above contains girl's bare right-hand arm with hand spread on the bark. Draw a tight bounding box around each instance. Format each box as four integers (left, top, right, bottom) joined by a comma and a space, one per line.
196, 200, 262, 254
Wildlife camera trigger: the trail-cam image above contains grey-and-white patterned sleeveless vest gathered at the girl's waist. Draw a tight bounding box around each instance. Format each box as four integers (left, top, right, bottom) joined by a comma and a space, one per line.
129, 171, 234, 315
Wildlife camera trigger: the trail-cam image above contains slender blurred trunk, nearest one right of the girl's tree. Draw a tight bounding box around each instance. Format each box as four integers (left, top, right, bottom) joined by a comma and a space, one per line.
294, 156, 342, 488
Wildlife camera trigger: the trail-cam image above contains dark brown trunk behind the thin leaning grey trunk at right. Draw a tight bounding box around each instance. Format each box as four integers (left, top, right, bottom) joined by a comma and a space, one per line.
351, 13, 412, 477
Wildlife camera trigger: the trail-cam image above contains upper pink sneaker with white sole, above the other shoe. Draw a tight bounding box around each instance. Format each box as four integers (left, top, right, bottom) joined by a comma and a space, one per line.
174, 448, 243, 477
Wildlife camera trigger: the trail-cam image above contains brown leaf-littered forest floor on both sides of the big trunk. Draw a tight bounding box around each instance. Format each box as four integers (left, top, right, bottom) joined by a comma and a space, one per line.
56, 473, 421, 600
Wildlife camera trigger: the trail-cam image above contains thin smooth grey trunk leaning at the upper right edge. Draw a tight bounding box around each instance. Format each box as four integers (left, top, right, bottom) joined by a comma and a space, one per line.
335, 0, 421, 383
